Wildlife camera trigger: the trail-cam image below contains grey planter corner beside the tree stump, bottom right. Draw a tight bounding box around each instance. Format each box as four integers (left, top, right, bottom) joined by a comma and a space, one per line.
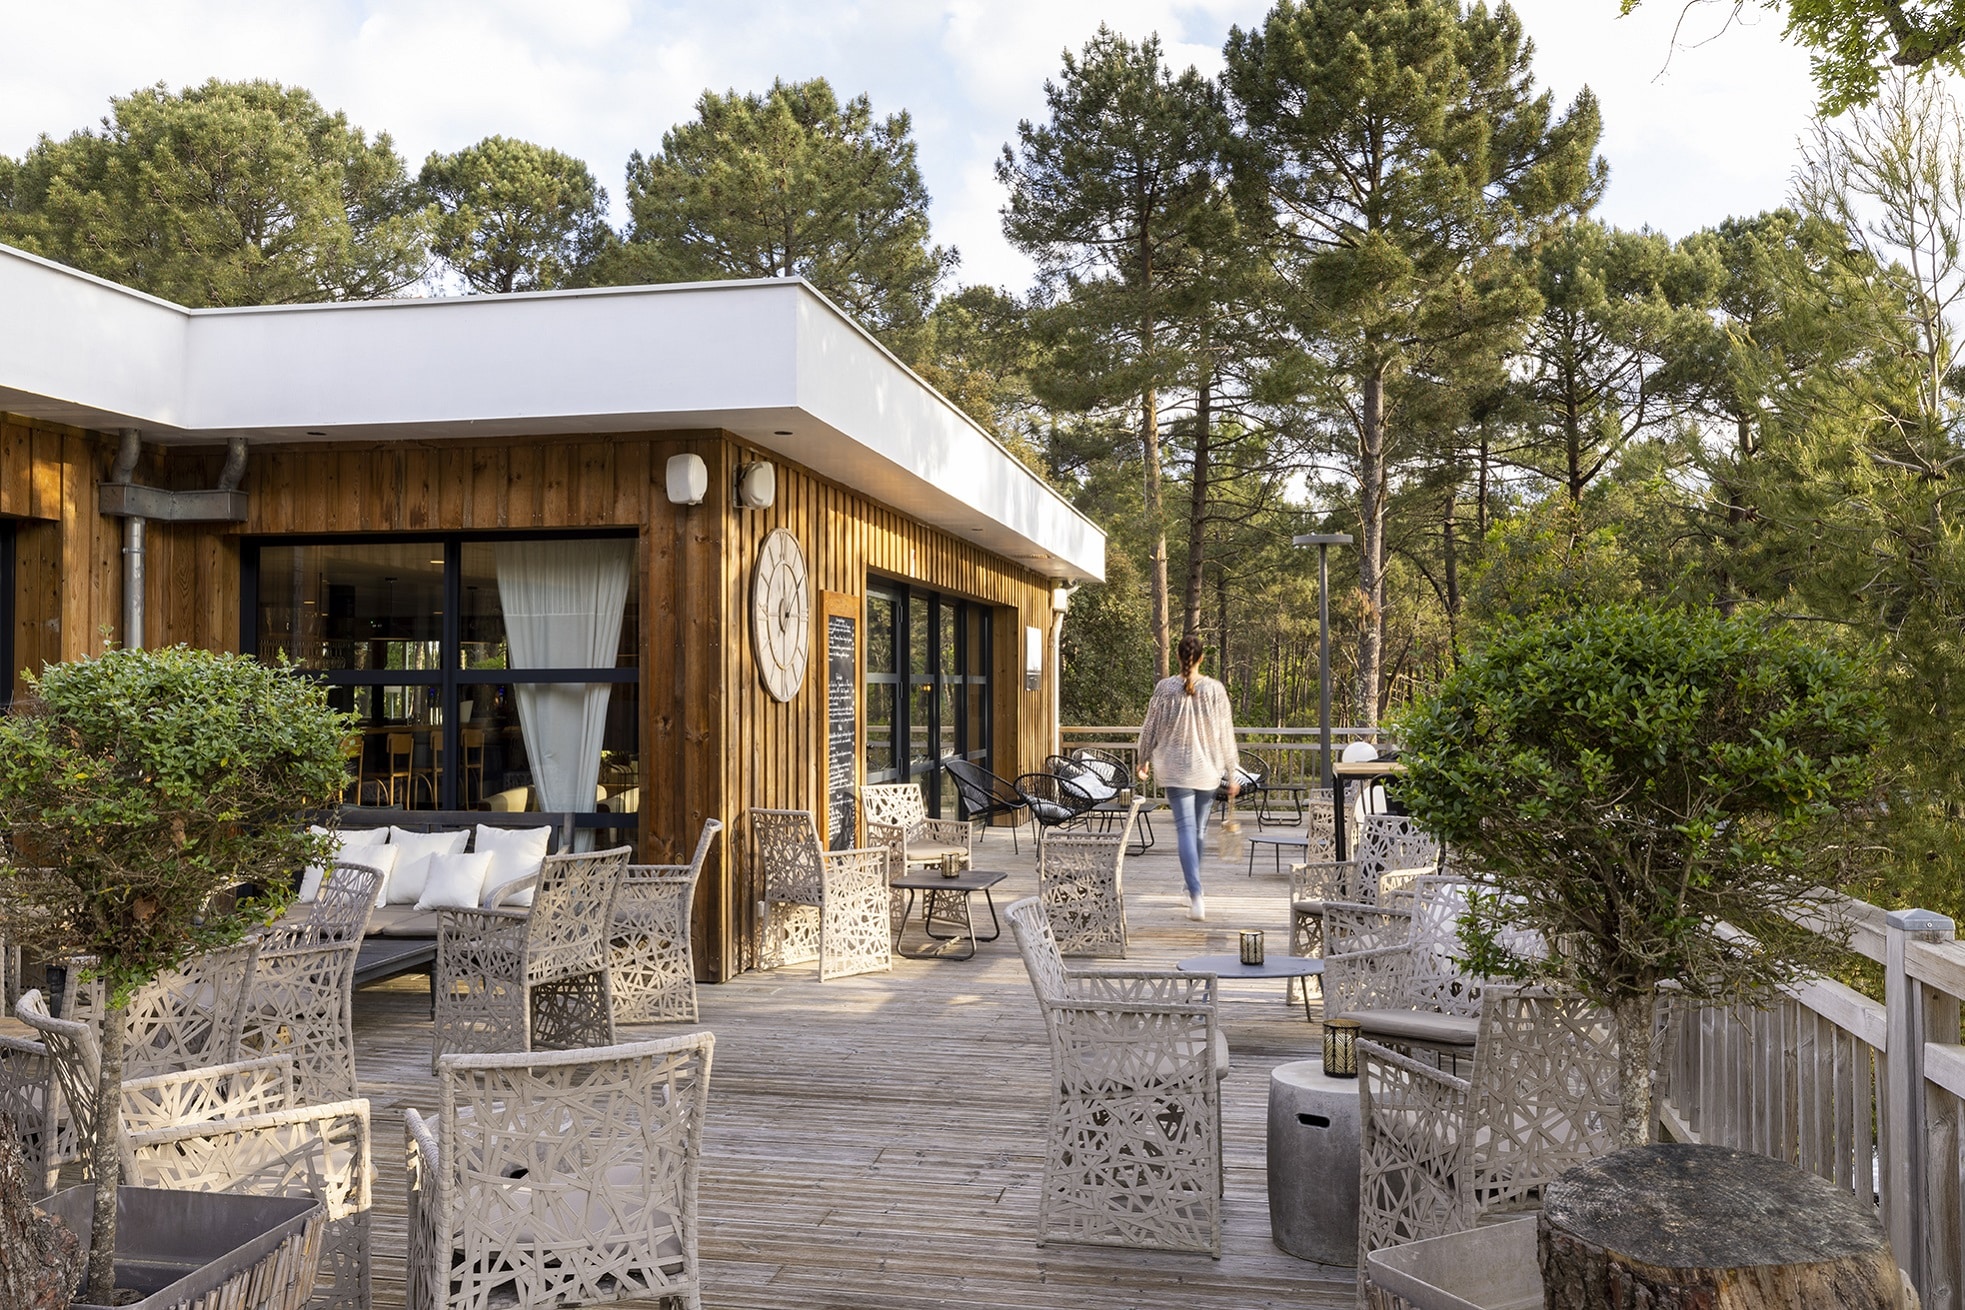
1366, 1220, 1543, 1310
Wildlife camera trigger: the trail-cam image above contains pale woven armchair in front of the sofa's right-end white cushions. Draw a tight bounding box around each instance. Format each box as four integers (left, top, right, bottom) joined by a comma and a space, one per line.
430, 846, 629, 1068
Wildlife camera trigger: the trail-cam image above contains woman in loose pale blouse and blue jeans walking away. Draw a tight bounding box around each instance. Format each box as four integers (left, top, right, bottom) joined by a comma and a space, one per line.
1140, 632, 1242, 919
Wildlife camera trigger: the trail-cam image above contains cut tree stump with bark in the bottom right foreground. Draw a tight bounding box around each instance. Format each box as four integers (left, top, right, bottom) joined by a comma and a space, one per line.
1539, 1145, 1916, 1310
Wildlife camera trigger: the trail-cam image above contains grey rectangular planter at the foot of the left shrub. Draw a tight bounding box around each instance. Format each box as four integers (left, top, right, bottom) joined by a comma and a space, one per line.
37, 1184, 328, 1310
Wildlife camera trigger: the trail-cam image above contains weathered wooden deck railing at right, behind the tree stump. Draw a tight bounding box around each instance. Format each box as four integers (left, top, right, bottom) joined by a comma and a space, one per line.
1658, 900, 1965, 1310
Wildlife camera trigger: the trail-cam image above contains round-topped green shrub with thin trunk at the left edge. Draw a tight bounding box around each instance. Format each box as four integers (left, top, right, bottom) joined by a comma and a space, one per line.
0, 646, 348, 1304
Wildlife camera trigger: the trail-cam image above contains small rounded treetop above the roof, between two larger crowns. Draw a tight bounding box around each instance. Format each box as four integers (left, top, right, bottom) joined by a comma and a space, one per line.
417, 136, 615, 293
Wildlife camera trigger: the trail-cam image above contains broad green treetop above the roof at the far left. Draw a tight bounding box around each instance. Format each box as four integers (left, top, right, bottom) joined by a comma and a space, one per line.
0, 79, 426, 306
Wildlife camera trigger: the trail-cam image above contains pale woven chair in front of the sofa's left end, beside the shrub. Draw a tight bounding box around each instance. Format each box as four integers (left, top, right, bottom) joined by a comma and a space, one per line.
242, 862, 381, 1102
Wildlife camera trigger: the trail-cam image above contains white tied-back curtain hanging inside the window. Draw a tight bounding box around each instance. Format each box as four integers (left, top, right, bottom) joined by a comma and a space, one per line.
497, 540, 635, 813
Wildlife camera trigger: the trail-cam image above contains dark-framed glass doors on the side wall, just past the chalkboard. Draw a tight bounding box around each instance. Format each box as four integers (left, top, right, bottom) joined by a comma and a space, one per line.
865, 583, 990, 815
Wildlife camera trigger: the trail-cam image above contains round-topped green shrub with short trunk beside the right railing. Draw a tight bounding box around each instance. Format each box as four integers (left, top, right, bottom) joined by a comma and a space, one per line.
1399, 605, 1881, 1145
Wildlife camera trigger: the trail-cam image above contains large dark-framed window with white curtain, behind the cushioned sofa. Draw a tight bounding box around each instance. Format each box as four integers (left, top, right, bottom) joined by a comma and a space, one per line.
244, 534, 641, 841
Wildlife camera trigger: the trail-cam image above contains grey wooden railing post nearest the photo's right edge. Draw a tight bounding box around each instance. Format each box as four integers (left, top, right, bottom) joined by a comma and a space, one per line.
1881, 909, 1959, 1296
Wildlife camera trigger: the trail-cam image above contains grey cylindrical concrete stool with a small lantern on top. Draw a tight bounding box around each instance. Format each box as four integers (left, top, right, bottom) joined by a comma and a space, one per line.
1269, 1059, 1358, 1267
